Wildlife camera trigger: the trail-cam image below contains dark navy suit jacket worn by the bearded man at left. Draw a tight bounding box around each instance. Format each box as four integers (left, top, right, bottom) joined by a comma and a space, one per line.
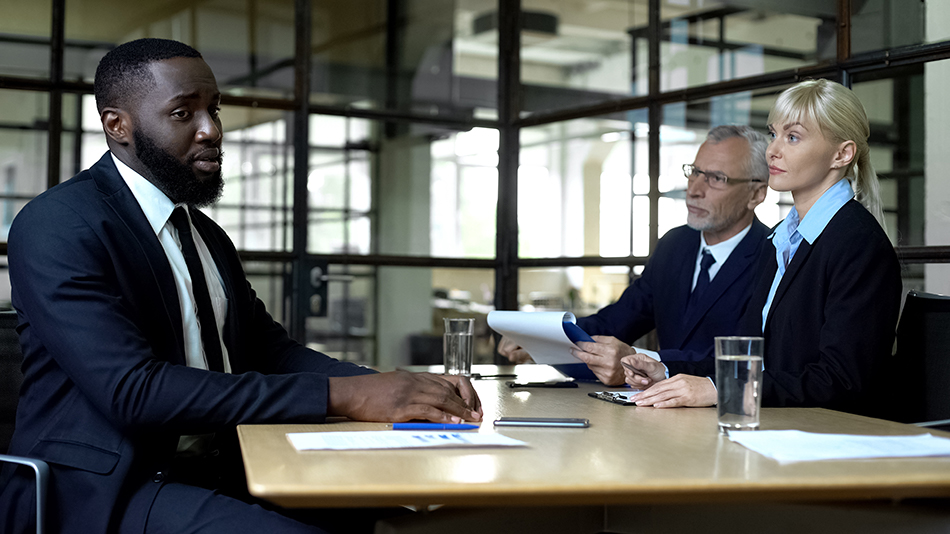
0, 153, 371, 533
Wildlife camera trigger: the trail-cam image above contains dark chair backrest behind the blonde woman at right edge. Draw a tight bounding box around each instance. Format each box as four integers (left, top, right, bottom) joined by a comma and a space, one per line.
891, 291, 950, 423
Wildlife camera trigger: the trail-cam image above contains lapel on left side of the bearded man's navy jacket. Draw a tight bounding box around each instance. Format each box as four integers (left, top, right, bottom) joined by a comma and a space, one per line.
89, 152, 185, 365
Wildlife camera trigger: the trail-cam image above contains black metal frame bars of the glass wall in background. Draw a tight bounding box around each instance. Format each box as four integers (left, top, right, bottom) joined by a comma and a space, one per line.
0, 0, 950, 364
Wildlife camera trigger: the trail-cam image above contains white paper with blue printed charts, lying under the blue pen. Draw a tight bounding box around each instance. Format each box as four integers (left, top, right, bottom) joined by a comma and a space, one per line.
287, 430, 527, 451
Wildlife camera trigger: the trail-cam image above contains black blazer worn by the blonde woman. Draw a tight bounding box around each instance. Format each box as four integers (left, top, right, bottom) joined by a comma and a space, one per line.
667, 200, 902, 414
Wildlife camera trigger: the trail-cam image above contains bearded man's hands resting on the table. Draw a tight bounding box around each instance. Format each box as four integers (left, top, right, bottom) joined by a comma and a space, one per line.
327, 371, 482, 423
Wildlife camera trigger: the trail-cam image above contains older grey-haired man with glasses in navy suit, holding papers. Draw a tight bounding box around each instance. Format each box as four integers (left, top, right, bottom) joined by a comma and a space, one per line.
498, 126, 769, 385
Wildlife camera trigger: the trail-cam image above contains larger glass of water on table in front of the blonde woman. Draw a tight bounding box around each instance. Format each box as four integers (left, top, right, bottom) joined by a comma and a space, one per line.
716, 336, 765, 431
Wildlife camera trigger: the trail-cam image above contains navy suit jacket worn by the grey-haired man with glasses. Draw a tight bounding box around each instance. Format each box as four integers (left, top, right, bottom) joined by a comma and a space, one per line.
577, 219, 768, 361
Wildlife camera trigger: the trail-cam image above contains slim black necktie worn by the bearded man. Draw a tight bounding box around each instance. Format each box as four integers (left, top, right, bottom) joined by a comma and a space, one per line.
170, 206, 224, 372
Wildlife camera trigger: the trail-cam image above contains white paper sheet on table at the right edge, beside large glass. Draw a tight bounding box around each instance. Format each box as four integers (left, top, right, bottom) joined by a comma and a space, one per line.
729, 430, 950, 463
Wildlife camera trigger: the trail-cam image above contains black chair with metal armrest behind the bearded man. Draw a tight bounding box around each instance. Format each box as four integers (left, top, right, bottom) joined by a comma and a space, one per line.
0, 311, 49, 534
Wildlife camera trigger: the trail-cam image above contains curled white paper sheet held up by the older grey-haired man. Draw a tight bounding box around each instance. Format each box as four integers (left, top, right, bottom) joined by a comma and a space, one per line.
488, 310, 582, 365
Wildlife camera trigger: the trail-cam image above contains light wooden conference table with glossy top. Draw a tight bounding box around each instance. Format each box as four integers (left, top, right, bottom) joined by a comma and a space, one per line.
238, 365, 950, 532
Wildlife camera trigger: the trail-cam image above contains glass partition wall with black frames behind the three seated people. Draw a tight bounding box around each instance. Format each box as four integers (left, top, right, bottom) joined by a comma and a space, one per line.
0, 0, 950, 369
